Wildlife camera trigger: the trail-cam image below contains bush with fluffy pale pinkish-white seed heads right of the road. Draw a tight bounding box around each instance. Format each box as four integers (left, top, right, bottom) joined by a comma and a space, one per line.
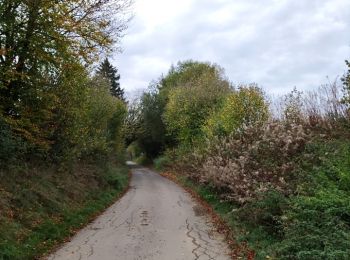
188, 122, 310, 203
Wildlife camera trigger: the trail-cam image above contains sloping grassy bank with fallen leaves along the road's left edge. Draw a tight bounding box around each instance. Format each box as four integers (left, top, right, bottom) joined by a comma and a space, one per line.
0, 163, 129, 260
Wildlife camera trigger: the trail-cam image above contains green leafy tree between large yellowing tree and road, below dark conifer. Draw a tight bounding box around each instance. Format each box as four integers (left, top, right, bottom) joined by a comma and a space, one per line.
52, 64, 126, 162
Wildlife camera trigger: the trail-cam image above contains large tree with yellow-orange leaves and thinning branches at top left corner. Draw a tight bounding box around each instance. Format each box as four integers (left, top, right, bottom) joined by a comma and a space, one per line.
0, 0, 130, 147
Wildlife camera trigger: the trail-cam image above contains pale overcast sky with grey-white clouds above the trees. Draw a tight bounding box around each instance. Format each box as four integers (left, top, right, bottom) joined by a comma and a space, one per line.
113, 0, 350, 99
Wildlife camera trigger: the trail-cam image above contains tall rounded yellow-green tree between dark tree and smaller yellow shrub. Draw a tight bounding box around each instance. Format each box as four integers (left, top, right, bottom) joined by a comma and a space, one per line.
163, 62, 231, 146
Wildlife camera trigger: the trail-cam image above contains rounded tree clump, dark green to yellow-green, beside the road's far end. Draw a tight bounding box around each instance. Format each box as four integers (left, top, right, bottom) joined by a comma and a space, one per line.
129, 60, 230, 159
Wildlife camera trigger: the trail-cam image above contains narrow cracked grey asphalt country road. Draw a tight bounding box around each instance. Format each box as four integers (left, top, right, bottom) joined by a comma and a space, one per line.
48, 168, 230, 260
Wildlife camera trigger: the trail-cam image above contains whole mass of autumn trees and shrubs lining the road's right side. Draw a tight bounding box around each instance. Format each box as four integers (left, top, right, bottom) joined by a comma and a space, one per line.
133, 61, 350, 259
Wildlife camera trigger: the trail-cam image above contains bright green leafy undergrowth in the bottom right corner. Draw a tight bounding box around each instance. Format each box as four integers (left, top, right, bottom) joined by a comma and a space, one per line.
276, 140, 350, 259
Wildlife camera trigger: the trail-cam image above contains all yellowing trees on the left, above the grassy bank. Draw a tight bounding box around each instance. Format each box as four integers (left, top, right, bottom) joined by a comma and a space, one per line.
0, 0, 130, 165
